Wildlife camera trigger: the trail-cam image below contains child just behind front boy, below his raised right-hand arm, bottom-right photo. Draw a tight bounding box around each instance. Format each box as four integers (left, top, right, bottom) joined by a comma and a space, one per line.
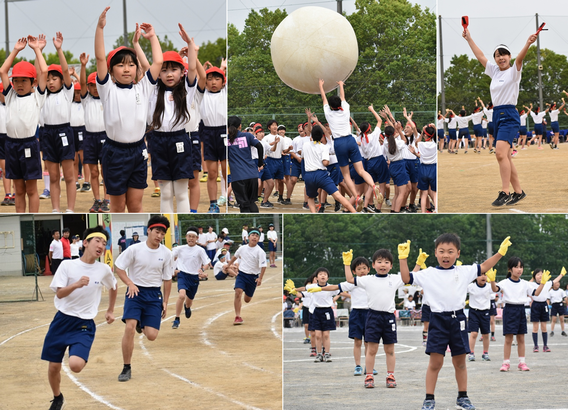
467, 275, 492, 362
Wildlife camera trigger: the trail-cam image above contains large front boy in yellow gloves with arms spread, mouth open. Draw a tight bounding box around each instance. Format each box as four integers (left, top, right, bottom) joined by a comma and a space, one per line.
398, 233, 511, 410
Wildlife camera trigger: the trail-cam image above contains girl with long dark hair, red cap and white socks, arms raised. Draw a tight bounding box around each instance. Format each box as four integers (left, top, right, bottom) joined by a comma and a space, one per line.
146, 24, 197, 213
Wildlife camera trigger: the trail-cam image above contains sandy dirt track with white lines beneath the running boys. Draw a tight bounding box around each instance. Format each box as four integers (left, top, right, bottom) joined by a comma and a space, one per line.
0, 261, 282, 410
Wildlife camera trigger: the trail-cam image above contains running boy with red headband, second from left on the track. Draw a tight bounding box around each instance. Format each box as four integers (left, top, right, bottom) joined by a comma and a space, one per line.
114, 215, 174, 382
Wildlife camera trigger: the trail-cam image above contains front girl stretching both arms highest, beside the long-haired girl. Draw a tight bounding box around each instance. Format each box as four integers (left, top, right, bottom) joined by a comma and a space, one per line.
95, 7, 163, 212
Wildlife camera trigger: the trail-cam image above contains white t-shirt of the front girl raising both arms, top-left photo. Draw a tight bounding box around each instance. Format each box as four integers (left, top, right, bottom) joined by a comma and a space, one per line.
97, 70, 157, 143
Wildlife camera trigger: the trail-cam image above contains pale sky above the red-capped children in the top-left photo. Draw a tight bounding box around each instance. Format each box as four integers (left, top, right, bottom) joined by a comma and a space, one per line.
0, 0, 227, 59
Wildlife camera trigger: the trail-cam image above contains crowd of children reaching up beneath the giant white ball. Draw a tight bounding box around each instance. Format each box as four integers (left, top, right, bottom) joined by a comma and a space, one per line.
228, 79, 437, 213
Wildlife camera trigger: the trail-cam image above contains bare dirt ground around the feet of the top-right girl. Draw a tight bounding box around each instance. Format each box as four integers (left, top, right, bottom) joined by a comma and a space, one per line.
438, 143, 568, 213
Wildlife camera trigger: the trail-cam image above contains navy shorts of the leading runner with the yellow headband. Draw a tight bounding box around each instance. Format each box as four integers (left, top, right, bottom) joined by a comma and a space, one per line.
41, 312, 97, 363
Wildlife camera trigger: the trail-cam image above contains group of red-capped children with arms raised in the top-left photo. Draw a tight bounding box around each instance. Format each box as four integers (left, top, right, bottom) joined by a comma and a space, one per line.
0, 7, 227, 213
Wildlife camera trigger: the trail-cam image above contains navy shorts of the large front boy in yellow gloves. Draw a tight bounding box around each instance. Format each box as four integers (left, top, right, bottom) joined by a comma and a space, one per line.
426, 310, 470, 356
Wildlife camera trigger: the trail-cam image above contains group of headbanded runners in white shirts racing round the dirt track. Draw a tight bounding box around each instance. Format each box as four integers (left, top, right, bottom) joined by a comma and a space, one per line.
41, 215, 266, 410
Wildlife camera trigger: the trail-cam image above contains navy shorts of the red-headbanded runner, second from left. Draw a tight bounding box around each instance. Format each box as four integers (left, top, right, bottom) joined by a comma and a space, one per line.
122, 286, 163, 330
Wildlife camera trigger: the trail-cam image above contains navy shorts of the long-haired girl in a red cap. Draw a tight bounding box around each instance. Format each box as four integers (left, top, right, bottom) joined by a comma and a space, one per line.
147, 130, 193, 181
